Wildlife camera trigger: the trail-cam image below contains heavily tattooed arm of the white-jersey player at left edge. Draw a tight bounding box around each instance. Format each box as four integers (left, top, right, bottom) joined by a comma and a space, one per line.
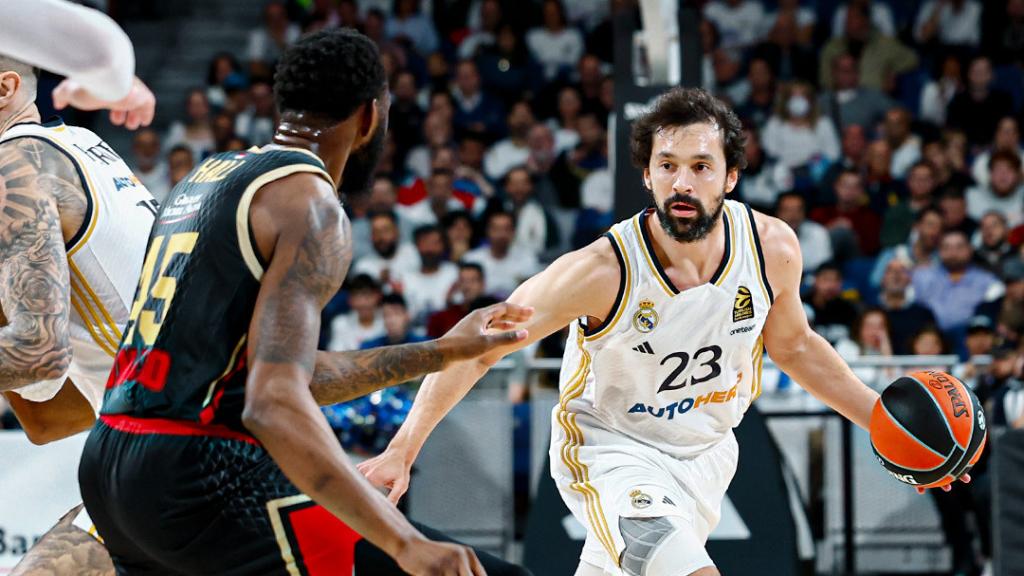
0, 138, 84, 389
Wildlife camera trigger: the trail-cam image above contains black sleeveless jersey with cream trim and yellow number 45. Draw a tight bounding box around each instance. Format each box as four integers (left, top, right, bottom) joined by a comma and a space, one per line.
101, 148, 331, 431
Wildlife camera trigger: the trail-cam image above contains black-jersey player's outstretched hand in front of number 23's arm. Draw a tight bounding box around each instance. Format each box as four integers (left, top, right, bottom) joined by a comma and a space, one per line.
438, 302, 534, 360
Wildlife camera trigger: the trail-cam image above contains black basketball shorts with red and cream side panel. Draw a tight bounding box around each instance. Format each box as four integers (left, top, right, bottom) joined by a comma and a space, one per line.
79, 416, 526, 576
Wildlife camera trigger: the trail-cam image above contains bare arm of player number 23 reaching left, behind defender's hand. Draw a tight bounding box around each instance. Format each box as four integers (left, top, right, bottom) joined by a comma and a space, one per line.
359, 238, 620, 501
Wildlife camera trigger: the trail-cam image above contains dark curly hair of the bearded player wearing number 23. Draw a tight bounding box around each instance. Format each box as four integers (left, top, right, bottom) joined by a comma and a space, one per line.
630, 88, 746, 170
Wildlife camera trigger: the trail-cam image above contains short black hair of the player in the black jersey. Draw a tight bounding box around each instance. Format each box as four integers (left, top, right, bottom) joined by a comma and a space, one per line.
273, 29, 387, 122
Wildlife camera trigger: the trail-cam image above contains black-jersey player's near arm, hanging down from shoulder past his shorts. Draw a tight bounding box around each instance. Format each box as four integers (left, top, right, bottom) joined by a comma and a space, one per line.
243, 174, 476, 575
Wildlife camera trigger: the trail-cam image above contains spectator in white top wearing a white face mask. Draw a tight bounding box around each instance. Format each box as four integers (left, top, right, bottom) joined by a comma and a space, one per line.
762, 82, 840, 168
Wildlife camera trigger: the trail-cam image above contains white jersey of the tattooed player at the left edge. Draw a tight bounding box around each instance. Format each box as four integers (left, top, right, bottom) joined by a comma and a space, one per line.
0, 120, 157, 411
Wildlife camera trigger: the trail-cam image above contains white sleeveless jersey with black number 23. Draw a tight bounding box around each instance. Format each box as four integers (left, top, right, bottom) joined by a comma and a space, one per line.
552, 200, 773, 458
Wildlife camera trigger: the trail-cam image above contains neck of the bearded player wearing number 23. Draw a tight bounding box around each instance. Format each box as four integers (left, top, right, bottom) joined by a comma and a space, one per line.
644, 208, 725, 290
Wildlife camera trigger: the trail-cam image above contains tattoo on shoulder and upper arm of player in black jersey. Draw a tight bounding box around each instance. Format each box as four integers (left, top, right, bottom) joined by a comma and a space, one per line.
253, 191, 351, 374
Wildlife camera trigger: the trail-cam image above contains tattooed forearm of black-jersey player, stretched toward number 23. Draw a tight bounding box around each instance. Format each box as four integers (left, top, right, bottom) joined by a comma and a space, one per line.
309, 340, 447, 406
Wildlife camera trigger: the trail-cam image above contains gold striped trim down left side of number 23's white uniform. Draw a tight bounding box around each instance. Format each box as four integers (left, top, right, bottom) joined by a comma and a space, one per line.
558, 324, 618, 565
